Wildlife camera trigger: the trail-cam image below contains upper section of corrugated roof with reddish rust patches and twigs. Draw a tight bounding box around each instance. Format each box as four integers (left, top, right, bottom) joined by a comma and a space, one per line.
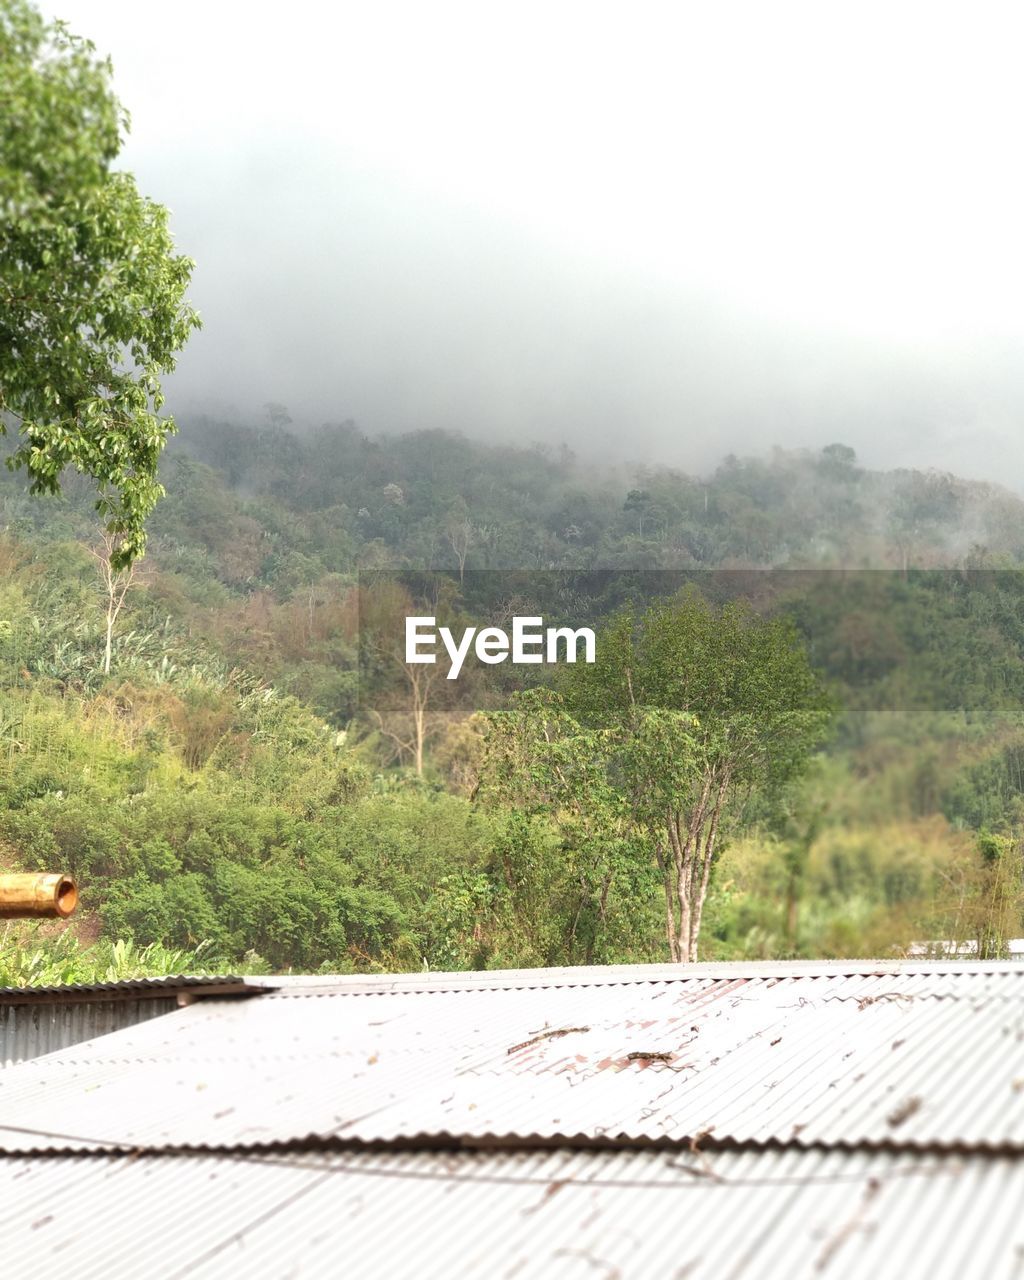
0, 961, 1024, 1151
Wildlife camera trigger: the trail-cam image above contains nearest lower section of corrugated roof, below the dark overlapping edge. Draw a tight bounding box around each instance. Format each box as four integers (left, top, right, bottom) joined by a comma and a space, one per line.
0, 1151, 1024, 1280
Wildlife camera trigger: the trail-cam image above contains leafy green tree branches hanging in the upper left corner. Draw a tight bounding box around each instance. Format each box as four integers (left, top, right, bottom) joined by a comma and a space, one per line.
0, 0, 198, 564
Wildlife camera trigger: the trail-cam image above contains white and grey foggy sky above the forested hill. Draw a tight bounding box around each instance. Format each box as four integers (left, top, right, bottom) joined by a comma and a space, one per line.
44, 0, 1024, 489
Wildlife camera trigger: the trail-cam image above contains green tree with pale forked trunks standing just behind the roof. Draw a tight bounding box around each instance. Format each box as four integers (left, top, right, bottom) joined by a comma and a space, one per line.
485, 593, 831, 961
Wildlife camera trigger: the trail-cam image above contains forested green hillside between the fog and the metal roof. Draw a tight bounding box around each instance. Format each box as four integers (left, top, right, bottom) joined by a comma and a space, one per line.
0, 404, 1024, 982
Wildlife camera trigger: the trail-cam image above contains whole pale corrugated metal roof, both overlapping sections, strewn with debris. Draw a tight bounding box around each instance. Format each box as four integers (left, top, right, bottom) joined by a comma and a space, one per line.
0, 960, 1024, 1280
